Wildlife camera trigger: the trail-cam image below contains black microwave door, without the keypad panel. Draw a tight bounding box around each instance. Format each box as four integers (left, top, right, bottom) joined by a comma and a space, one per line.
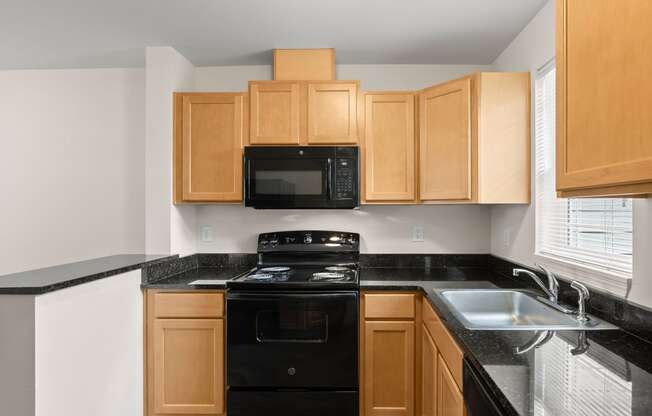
245, 147, 335, 208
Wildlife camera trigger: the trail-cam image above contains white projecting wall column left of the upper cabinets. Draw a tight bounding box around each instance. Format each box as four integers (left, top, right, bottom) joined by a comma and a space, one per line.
145, 46, 197, 256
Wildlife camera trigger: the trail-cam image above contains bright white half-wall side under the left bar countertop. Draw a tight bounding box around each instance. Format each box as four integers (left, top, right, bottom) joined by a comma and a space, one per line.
34, 270, 143, 416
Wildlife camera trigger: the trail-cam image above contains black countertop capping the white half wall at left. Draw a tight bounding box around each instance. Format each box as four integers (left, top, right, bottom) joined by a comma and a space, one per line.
0, 254, 177, 295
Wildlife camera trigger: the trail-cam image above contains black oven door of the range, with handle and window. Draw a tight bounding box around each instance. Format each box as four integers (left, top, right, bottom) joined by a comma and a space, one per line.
226, 292, 358, 389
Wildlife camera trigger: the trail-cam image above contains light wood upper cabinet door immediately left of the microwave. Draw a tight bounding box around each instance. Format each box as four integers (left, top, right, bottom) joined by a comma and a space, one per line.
182, 94, 244, 201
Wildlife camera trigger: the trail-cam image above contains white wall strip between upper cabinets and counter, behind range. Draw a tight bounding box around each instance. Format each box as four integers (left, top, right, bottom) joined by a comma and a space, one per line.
197, 205, 490, 253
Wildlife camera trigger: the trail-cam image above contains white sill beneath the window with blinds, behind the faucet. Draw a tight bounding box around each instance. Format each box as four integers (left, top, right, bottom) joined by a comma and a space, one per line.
534, 253, 632, 298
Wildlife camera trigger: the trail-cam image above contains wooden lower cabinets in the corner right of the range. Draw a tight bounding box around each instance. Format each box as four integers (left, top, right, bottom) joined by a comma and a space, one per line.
360, 292, 466, 416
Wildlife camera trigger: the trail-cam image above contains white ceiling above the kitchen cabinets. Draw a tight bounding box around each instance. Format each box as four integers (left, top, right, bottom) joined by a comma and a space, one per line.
0, 0, 547, 69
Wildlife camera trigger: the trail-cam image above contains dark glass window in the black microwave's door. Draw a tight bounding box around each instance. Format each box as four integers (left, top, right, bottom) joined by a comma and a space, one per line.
256, 170, 324, 195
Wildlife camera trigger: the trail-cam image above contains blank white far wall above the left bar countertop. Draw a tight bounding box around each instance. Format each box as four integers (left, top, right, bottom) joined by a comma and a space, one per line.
0, 69, 145, 275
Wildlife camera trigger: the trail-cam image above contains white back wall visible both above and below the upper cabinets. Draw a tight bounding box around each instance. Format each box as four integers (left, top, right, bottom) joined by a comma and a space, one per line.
195, 65, 491, 253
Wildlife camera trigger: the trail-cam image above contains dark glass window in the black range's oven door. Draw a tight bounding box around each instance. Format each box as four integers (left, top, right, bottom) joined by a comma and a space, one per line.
256, 306, 328, 343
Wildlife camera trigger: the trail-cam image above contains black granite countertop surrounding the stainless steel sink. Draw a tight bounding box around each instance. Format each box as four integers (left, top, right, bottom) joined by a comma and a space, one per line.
360, 268, 652, 416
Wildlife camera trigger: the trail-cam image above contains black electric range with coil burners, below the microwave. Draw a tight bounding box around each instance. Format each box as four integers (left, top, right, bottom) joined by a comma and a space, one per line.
226, 231, 360, 416
